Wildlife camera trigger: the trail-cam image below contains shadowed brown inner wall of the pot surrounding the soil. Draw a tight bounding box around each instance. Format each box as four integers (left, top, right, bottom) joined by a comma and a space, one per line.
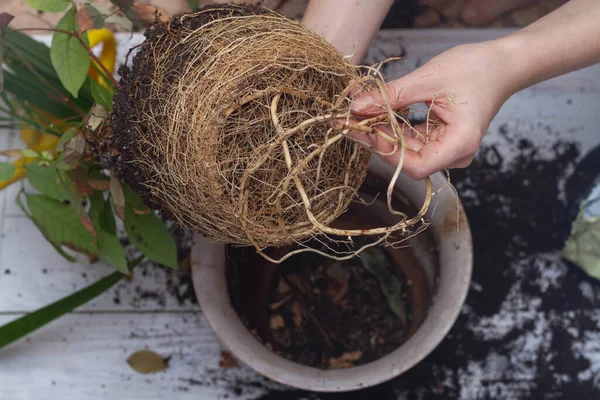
227, 173, 439, 368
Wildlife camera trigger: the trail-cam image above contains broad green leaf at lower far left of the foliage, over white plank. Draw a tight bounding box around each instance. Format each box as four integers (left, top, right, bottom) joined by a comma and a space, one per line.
25, 194, 97, 254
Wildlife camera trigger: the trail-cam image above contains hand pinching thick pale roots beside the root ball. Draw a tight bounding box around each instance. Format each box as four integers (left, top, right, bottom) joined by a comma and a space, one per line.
349, 41, 519, 179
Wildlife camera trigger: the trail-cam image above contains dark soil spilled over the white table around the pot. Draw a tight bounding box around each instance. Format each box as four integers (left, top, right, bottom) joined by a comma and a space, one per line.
106, 117, 600, 400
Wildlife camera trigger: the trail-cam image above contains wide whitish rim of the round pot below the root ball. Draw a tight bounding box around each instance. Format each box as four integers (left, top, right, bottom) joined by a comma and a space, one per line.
192, 159, 473, 392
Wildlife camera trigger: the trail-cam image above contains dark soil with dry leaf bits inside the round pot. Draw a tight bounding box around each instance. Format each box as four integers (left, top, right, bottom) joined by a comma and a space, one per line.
268, 243, 412, 369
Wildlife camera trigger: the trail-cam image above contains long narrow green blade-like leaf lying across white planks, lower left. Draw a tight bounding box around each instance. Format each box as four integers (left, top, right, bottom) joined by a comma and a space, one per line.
0, 272, 123, 348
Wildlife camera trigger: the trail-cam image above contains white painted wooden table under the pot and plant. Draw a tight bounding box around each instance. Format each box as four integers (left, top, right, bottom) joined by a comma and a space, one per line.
0, 30, 600, 400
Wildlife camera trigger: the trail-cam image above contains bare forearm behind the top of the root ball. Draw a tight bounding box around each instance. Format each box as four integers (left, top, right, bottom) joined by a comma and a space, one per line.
302, 0, 394, 64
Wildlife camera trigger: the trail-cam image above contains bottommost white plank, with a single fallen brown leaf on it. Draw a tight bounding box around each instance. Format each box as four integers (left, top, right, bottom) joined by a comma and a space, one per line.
0, 312, 283, 400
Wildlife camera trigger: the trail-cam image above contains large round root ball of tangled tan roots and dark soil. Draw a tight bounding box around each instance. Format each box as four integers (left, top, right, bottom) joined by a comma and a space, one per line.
111, 5, 431, 261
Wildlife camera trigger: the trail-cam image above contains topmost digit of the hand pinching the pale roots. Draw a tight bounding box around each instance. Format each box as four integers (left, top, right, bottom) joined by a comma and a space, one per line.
352, 70, 432, 116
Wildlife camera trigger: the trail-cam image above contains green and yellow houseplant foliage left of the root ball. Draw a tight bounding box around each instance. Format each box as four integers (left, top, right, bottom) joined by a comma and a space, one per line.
0, 0, 178, 347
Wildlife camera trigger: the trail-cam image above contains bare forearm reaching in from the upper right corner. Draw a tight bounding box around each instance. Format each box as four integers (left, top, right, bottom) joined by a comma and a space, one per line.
495, 0, 600, 91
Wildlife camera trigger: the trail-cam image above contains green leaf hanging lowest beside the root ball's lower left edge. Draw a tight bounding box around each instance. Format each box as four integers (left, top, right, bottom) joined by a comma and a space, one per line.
125, 188, 178, 268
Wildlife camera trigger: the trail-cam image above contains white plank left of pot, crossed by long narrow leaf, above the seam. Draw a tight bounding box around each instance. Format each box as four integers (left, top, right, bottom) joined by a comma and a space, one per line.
0, 217, 197, 312
